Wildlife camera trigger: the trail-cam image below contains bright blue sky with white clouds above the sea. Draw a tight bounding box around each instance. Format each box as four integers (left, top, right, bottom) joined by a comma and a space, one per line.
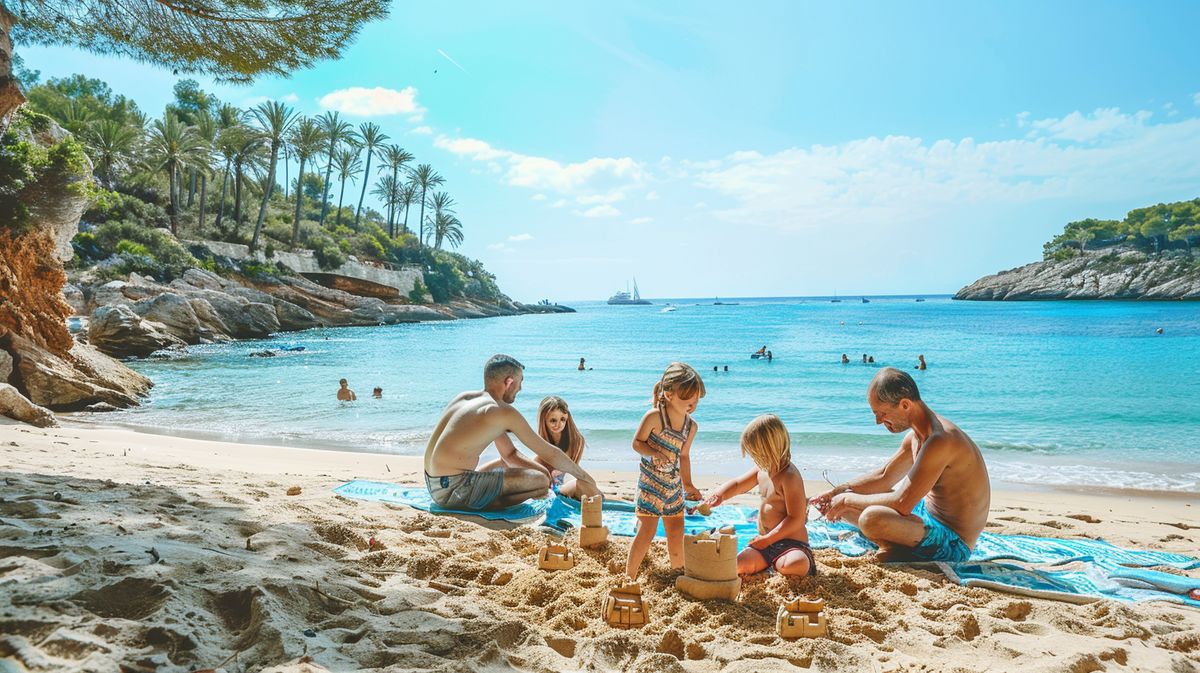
18, 0, 1200, 302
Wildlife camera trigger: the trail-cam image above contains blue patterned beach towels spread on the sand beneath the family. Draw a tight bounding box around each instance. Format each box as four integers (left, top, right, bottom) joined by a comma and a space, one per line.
334, 480, 1200, 608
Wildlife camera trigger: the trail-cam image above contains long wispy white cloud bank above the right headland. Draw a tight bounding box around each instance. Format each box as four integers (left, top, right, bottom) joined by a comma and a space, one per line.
689, 109, 1200, 229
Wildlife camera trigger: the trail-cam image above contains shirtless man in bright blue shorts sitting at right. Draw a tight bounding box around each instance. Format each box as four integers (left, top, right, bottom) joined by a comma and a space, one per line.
811, 367, 991, 561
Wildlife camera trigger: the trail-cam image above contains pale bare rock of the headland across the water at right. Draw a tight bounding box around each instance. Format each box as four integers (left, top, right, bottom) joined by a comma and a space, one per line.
954, 247, 1200, 301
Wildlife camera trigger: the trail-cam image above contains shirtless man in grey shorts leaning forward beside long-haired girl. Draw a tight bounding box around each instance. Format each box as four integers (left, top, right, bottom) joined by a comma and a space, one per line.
425, 355, 600, 510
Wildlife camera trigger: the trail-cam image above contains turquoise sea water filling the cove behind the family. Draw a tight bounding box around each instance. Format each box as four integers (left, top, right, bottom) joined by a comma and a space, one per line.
75, 296, 1200, 492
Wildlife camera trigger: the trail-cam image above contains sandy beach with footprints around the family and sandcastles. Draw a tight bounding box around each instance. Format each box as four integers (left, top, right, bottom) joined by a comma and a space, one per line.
0, 423, 1200, 673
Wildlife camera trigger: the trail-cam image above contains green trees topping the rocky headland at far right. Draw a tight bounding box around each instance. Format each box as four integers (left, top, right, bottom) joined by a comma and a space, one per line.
1043, 198, 1200, 260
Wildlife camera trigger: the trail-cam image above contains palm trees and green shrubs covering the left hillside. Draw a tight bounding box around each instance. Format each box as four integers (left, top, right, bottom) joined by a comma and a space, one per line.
22, 70, 500, 302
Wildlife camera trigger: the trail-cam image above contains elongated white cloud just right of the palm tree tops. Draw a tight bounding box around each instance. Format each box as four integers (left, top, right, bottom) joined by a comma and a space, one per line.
433, 136, 646, 200
